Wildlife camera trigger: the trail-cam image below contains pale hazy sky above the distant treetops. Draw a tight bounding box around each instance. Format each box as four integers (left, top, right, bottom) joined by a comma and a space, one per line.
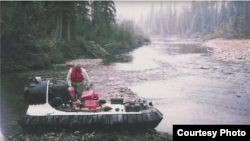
114, 0, 190, 20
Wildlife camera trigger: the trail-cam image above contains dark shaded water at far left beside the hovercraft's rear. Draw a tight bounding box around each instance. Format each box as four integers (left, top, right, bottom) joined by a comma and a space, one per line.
0, 73, 27, 138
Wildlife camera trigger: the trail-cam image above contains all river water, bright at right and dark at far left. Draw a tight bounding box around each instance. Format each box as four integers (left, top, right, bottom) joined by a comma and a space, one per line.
0, 39, 250, 140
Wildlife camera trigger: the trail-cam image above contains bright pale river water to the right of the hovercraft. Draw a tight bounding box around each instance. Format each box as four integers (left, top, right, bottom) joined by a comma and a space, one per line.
113, 40, 250, 133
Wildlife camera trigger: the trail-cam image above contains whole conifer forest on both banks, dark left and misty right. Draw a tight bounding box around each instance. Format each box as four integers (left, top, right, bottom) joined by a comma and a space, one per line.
0, 0, 250, 72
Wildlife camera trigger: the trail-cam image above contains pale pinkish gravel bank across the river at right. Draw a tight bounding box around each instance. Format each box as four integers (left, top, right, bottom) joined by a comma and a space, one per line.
204, 38, 250, 64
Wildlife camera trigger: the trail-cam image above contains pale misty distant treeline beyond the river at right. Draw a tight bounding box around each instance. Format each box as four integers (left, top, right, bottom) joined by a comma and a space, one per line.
141, 0, 250, 39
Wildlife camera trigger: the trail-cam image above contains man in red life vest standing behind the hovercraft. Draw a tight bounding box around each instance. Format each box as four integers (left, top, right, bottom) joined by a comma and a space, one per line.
67, 64, 90, 98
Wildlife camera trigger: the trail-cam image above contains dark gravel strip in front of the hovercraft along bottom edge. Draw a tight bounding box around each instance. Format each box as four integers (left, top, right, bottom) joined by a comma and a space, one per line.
8, 130, 173, 141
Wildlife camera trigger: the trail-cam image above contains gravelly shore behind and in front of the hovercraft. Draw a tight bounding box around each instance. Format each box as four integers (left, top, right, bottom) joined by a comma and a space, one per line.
3, 58, 172, 141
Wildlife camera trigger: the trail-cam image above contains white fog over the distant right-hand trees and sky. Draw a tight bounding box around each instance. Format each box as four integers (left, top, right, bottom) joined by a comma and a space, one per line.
114, 0, 250, 39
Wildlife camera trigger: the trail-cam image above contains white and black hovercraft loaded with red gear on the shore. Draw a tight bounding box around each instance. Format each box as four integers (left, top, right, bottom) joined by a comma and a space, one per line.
18, 77, 163, 129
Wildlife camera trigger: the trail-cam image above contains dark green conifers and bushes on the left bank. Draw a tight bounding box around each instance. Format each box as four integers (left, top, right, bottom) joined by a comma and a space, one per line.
0, 0, 147, 72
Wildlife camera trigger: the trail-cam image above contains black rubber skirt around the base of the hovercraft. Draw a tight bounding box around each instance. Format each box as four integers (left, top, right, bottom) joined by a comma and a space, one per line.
18, 107, 163, 129
